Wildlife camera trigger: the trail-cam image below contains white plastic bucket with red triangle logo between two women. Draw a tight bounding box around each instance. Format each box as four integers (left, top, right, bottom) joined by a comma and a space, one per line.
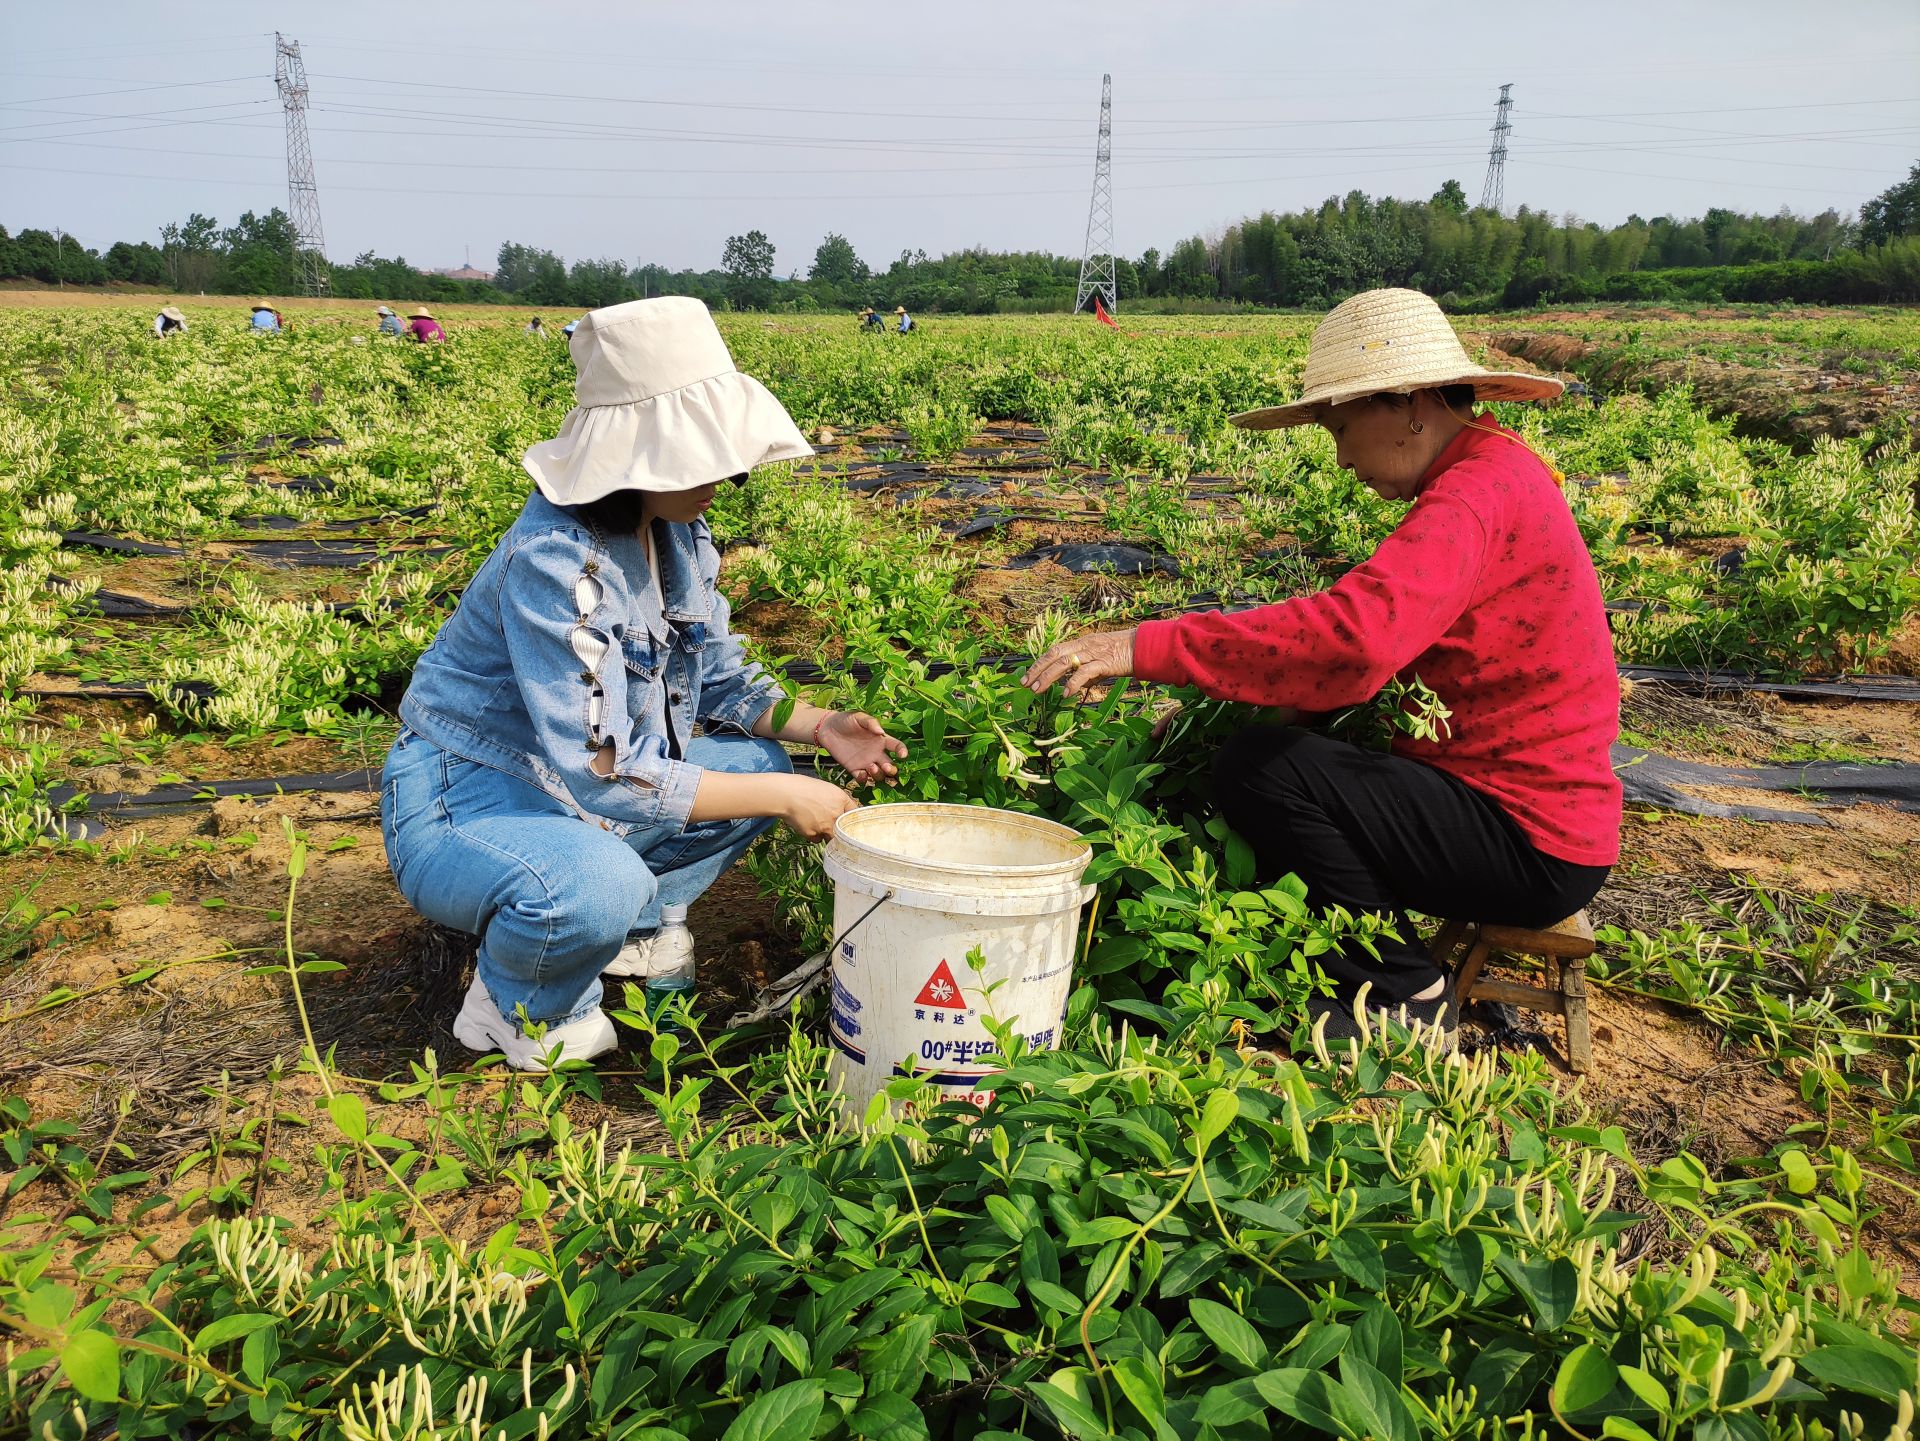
826, 802, 1094, 1117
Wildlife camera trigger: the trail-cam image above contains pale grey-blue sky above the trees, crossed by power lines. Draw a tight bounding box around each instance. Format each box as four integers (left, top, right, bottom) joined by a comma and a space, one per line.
0, 0, 1920, 274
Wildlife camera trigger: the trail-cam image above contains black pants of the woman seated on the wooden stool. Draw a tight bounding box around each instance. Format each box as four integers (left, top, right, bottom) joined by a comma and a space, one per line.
1213, 725, 1611, 1004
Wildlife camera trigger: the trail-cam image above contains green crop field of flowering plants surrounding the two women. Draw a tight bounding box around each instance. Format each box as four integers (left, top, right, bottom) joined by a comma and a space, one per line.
0, 295, 1920, 1441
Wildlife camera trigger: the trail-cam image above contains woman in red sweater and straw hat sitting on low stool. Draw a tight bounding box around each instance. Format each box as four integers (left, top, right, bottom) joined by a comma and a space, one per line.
1025, 290, 1620, 1036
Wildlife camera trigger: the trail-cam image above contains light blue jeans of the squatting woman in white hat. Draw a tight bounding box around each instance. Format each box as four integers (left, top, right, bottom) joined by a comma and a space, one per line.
380, 729, 793, 1025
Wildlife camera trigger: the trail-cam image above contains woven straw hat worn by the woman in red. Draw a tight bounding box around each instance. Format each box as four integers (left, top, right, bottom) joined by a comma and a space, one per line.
1233, 290, 1561, 430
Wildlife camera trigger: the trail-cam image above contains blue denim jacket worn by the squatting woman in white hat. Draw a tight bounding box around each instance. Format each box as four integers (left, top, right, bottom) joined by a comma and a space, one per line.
399, 491, 781, 827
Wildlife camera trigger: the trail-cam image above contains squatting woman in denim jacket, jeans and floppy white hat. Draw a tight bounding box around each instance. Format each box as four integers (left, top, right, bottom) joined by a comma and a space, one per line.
380, 297, 906, 1069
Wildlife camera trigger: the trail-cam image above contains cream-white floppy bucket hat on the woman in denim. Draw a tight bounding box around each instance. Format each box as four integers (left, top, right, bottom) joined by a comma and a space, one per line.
520, 295, 814, 505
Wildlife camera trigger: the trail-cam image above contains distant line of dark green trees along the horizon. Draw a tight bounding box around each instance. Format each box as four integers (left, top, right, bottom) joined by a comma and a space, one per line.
0, 163, 1920, 315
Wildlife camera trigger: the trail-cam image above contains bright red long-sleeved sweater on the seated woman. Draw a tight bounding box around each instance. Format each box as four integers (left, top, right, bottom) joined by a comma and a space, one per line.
1133, 420, 1620, 865
